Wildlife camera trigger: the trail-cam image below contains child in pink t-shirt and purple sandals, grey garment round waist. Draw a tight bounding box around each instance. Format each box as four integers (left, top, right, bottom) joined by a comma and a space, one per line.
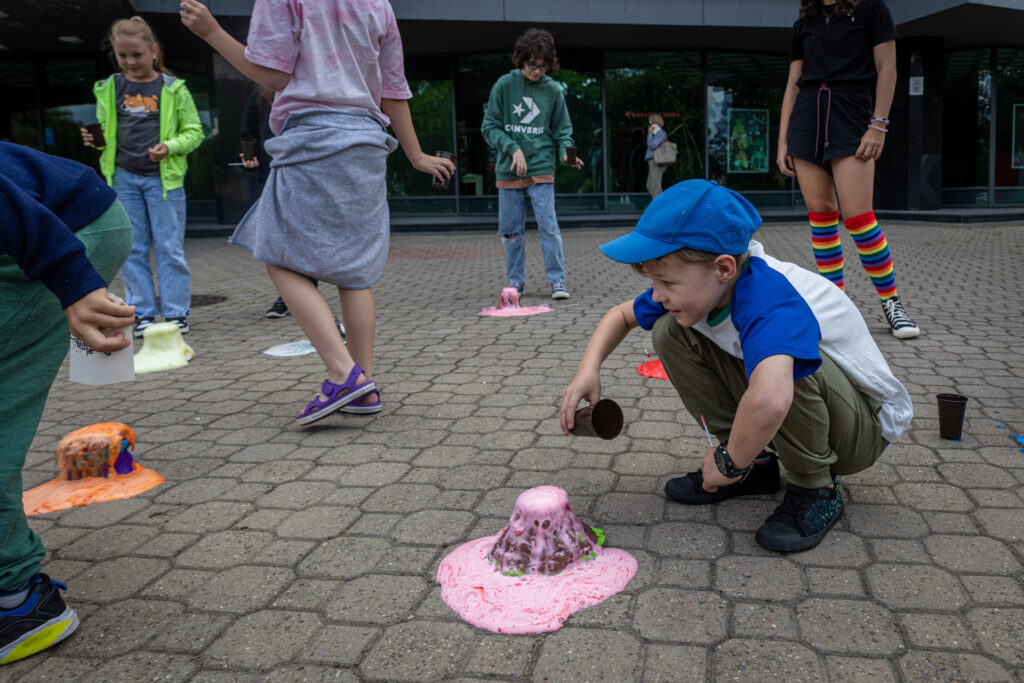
181, 0, 455, 425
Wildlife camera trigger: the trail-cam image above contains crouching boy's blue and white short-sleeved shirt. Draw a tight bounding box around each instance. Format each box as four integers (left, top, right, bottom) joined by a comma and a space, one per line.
633, 240, 913, 442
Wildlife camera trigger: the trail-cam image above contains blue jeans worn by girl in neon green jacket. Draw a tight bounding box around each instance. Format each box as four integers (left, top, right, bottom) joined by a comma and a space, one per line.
114, 168, 191, 318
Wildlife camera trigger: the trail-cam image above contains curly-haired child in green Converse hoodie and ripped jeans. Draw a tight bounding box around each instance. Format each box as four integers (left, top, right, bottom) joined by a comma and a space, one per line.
480, 29, 583, 299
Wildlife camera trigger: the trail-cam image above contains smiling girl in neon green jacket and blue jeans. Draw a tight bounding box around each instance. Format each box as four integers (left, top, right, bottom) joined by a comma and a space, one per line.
82, 16, 203, 337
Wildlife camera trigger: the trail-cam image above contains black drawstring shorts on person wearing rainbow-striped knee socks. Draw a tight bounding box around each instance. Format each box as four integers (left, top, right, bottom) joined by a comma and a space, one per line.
786, 85, 874, 172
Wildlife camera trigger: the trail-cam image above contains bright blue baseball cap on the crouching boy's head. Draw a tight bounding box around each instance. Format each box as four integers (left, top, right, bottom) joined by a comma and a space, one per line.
600, 179, 761, 263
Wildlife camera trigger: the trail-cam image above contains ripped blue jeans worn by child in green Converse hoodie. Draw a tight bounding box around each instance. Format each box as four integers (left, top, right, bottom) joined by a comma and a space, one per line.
498, 182, 565, 288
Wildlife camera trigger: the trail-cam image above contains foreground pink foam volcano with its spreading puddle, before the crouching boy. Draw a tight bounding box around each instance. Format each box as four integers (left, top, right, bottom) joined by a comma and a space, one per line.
437, 486, 637, 633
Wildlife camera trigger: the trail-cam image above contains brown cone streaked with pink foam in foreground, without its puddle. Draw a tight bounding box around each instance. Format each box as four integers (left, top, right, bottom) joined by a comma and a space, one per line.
487, 486, 599, 575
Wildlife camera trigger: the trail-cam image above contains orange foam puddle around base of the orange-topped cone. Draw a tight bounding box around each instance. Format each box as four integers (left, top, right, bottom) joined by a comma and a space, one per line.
22, 463, 164, 515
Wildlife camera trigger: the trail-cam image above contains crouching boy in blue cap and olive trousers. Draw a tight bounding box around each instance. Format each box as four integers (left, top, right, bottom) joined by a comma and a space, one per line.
560, 180, 913, 552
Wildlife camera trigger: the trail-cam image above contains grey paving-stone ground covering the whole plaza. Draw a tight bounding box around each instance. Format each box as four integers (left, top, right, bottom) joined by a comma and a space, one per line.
8, 223, 1024, 683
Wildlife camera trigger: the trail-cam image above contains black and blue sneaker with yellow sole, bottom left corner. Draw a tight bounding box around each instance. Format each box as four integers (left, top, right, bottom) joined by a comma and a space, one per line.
0, 573, 78, 663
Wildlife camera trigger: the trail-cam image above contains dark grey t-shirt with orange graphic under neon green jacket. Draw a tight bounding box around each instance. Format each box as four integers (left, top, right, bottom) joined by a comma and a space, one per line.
114, 74, 164, 175
